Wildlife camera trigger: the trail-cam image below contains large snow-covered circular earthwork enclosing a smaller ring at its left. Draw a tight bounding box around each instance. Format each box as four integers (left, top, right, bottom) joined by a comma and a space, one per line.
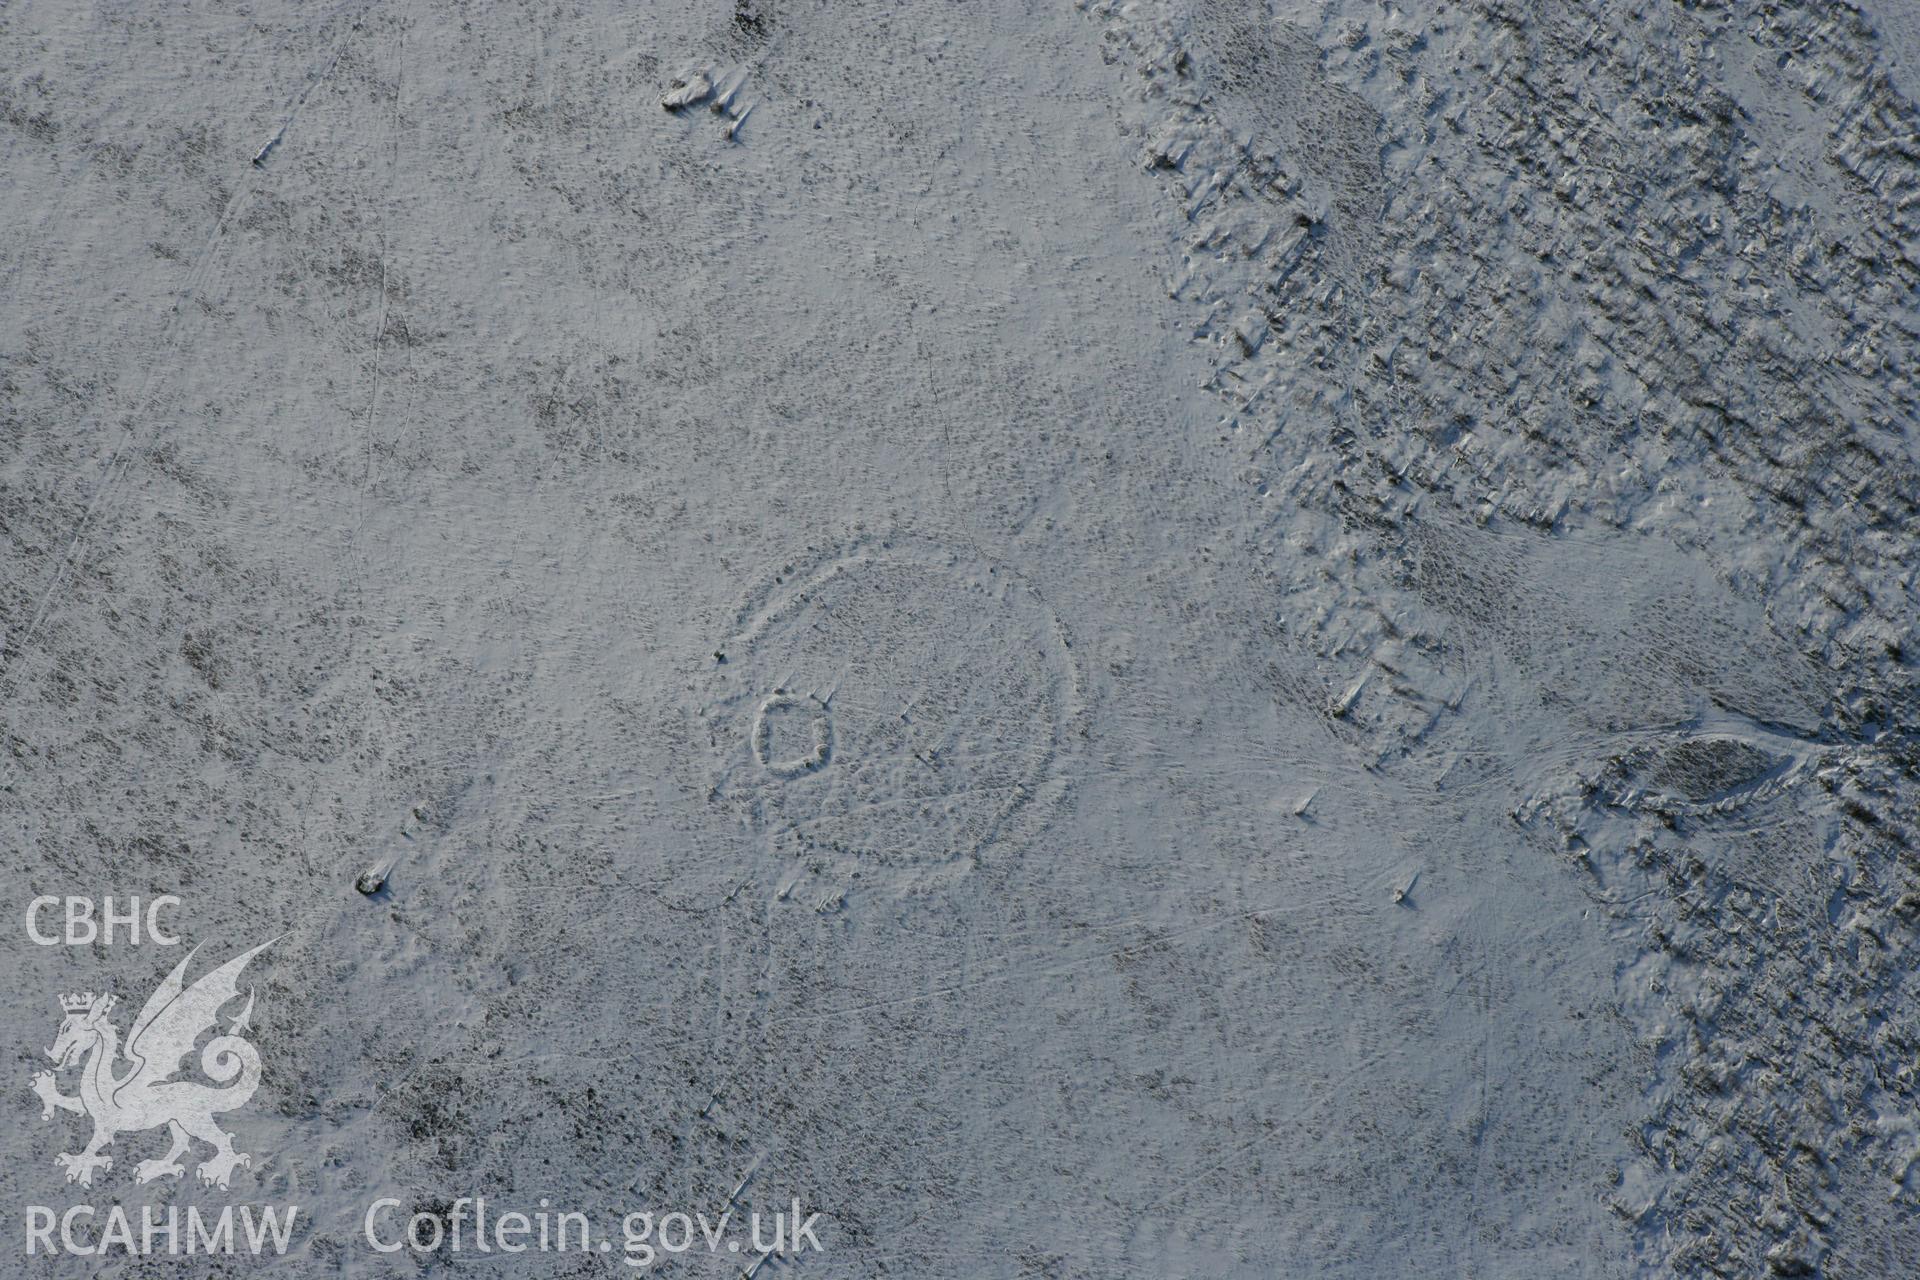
705, 551, 1075, 864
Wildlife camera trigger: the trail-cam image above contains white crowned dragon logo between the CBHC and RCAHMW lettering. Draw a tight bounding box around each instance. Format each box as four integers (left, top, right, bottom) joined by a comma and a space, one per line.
33, 940, 273, 1188
